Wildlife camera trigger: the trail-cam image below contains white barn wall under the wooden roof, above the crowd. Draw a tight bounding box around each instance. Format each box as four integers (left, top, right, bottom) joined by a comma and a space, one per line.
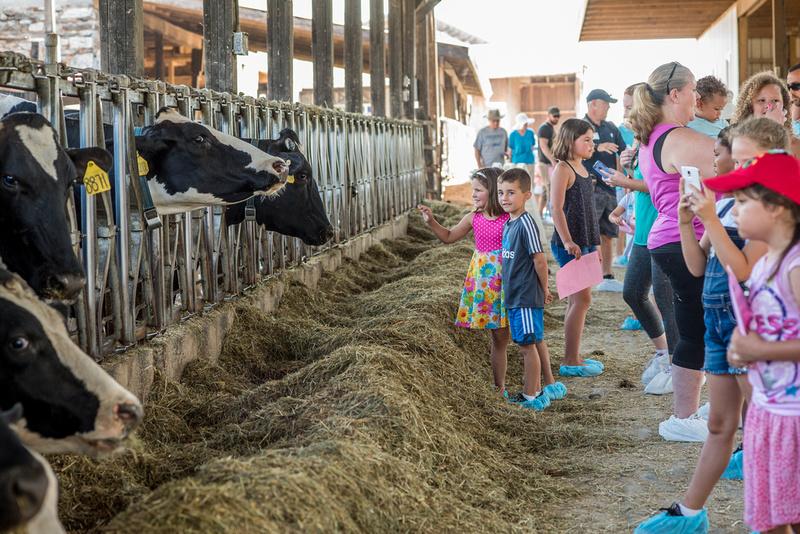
695, 5, 739, 118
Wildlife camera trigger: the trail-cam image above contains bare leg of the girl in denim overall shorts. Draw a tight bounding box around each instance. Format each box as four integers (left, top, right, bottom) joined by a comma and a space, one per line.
683, 374, 744, 510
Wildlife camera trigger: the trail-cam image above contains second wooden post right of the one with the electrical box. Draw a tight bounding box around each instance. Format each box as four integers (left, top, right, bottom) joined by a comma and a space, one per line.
311, 0, 333, 108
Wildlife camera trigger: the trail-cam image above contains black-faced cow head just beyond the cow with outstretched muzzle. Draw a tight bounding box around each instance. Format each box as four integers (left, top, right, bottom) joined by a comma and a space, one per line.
226, 128, 333, 246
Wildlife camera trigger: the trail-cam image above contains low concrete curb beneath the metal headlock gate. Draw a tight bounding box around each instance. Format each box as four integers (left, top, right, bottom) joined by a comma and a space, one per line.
103, 215, 408, 402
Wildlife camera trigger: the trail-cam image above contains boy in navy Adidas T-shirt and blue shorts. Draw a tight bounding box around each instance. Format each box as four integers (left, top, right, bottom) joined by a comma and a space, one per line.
497, 169, 567, 411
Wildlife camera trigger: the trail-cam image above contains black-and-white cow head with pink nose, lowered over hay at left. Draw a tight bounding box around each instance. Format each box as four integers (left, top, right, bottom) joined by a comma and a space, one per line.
0, 268, 142, 455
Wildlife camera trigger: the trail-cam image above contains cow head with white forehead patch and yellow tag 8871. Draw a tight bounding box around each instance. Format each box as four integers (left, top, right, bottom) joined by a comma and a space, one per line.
0, 113, 111, 300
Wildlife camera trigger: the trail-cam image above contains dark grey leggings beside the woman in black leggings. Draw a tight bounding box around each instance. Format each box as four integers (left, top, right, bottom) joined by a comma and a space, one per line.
622, 245, 678, 354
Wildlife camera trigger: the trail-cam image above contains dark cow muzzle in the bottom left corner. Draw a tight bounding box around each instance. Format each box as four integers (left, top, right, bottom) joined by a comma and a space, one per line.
0, 404, 49, 532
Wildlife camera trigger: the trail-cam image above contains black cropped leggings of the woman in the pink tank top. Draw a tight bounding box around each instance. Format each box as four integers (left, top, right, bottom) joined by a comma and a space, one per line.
650, 243, 706, 371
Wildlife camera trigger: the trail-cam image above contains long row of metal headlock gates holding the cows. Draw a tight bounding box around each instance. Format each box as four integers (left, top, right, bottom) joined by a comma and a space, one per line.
0, 52, 425, 359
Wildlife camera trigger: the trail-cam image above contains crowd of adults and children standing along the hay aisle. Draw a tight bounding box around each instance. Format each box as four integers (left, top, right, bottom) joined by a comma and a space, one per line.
432, 62, 800, 533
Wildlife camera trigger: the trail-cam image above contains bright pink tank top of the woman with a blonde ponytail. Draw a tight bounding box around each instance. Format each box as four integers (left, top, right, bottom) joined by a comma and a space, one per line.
639, 123, 703, 250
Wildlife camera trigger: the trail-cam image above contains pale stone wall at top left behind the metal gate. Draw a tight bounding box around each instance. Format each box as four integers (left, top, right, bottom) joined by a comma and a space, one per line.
0, 0, 100, 69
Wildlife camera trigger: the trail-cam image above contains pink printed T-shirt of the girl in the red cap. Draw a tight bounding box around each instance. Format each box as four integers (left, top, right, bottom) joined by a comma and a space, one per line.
747, 244, 800, 416
